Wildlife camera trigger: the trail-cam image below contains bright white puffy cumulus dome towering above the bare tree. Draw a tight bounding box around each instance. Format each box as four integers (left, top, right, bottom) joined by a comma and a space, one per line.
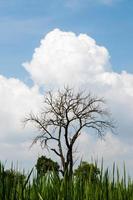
24, 29, 109, 86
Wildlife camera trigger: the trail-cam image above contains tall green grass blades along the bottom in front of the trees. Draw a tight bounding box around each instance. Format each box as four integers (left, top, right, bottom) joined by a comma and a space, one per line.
0, 164, 133, 200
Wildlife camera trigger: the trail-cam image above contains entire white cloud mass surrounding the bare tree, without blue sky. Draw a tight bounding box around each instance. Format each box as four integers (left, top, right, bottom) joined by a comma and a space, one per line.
0, 29, 133, 175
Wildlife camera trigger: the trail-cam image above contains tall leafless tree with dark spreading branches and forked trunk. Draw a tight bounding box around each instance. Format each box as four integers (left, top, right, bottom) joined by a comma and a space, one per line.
25, 87, 114, 176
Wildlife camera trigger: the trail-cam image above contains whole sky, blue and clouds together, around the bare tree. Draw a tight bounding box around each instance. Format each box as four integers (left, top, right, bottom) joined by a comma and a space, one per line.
0, 0, 133, 175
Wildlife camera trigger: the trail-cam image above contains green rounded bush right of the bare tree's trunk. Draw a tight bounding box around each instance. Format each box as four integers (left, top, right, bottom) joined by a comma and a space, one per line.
74, 161, 100, 183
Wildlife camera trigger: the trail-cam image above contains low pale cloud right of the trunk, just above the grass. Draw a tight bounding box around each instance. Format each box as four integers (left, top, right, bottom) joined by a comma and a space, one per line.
76, 132, 133, 176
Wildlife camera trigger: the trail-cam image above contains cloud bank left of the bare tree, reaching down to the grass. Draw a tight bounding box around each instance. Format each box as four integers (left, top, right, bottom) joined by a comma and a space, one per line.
0, 76, 42, 169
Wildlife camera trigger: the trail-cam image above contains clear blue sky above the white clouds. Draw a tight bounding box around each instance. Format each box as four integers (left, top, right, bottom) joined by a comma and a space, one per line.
0, 0, 133, 79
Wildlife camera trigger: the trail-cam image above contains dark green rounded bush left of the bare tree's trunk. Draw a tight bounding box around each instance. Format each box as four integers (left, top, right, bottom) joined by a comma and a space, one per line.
36, 156, 59, 176
